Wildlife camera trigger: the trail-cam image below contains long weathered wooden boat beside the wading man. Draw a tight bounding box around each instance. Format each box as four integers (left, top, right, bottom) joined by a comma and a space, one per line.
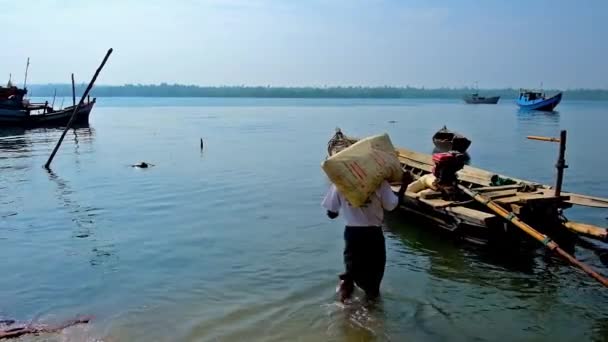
328, 130, 608, 246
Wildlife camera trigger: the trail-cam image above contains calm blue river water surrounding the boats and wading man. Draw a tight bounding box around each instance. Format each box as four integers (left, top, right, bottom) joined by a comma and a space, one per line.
0, 99, 608, 341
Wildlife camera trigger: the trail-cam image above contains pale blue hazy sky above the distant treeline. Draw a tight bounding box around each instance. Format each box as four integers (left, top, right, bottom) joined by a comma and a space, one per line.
0, 0, 608, 89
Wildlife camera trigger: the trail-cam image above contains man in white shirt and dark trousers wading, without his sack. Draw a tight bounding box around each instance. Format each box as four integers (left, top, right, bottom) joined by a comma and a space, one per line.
322, 172, 412, 302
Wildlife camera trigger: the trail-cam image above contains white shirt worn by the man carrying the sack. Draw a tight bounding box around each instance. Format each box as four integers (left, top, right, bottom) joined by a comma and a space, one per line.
321, 181, 399, 227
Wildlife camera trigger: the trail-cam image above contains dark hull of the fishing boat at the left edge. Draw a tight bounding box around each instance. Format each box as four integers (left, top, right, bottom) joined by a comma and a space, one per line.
0, 99, 95, 127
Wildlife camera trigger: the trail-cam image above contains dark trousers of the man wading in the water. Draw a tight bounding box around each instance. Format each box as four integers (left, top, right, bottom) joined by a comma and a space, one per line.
340, 226, 386, 298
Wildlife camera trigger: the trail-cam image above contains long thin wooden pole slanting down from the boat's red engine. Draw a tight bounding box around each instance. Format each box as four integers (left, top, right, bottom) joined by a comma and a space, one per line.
458, 184, 608, 287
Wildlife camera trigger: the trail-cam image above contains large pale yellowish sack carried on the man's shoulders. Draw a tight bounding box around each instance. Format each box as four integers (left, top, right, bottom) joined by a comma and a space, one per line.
321, 133, 403, 207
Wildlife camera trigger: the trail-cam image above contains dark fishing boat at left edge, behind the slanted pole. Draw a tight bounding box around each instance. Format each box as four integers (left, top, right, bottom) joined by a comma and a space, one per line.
0, 81, 96, 127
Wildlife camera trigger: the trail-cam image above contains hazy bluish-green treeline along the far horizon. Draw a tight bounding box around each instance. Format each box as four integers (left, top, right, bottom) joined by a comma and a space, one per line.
28, 83, 608, 101
